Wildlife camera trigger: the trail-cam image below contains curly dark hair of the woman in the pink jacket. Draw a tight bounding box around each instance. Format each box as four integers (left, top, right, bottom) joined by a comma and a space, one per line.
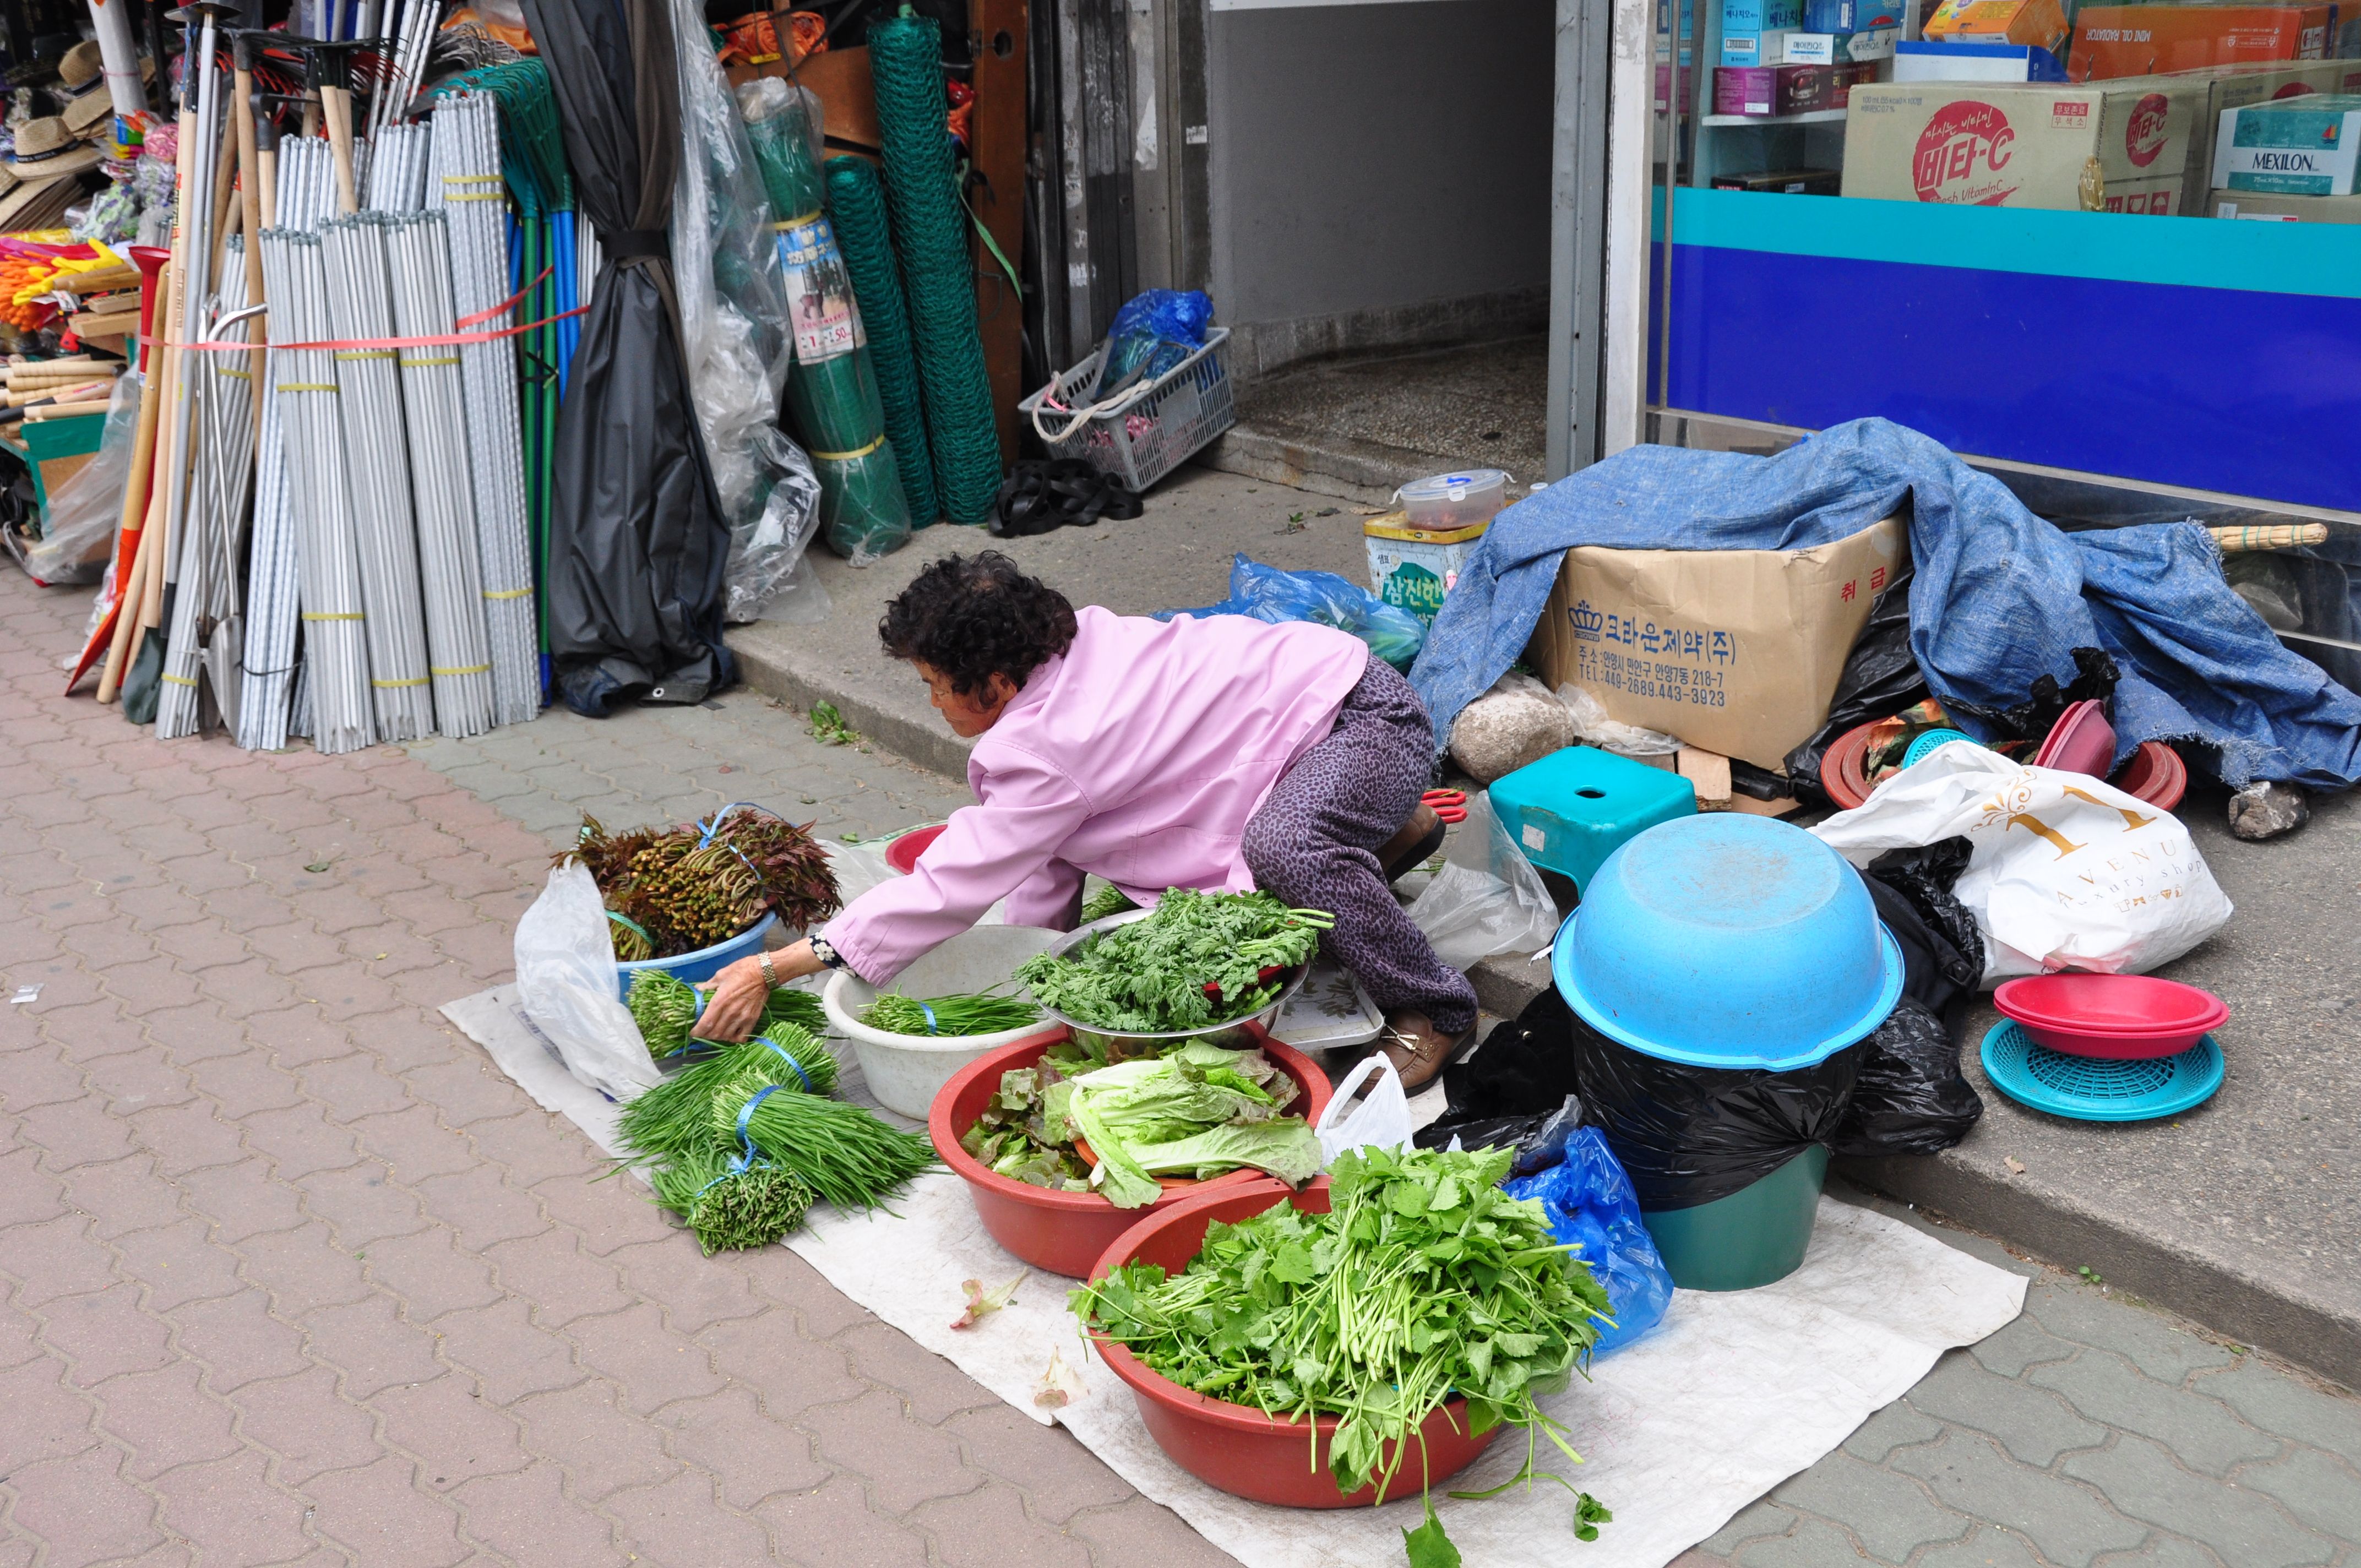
878, 550, 1074, 696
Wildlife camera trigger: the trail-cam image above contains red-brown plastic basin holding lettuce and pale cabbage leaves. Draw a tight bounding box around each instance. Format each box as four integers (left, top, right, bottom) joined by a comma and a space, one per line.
926, 1025, 1329, 1280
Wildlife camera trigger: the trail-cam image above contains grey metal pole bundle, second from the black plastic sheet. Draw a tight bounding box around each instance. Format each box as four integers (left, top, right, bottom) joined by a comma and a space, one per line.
385, 213, 493, 739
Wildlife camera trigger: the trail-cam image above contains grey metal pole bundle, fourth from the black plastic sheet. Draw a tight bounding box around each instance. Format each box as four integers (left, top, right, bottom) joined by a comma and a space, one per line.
262, 225, 378, 751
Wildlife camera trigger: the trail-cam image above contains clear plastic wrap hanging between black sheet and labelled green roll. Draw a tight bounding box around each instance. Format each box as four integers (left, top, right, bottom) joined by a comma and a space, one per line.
673, 0, 819, 621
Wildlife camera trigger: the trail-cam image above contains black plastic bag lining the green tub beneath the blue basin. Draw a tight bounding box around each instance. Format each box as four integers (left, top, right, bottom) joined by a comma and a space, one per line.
1520, 989, 1870, 1211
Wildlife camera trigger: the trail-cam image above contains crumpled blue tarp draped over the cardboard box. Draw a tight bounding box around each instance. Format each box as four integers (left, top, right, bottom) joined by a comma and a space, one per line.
1410, 420, 2361, 789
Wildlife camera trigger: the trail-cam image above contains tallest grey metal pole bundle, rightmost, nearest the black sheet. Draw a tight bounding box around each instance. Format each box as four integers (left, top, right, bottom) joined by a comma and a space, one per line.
427, 95, 541, 725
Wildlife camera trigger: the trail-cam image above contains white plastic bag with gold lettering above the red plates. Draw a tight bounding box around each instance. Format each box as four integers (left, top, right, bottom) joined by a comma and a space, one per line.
1811, 742, 2231, 985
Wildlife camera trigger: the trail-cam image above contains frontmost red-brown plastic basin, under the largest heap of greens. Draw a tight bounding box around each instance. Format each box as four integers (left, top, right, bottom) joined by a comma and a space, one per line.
1091, 1176, 1506, 1509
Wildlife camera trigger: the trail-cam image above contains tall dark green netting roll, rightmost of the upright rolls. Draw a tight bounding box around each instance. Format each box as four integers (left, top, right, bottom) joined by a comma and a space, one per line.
869, 17, 1001, 522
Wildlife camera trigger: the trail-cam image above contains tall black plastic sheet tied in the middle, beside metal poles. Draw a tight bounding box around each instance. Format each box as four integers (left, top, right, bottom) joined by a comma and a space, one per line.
524, 0, 737, 718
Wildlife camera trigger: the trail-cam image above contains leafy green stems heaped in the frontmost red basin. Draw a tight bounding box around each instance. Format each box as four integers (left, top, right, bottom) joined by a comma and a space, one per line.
1072, 1145, 1608, 1501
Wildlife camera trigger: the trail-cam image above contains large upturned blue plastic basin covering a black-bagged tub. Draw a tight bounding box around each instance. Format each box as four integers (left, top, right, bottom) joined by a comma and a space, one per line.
1551, 812, 1903, 1070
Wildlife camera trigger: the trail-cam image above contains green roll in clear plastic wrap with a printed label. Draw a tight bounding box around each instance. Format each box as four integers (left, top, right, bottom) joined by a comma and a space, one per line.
739, 78, 911, 567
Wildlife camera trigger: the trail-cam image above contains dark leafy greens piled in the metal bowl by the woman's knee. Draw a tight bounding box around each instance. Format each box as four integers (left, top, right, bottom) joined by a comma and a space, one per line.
1015, 888, 1334, 1035
